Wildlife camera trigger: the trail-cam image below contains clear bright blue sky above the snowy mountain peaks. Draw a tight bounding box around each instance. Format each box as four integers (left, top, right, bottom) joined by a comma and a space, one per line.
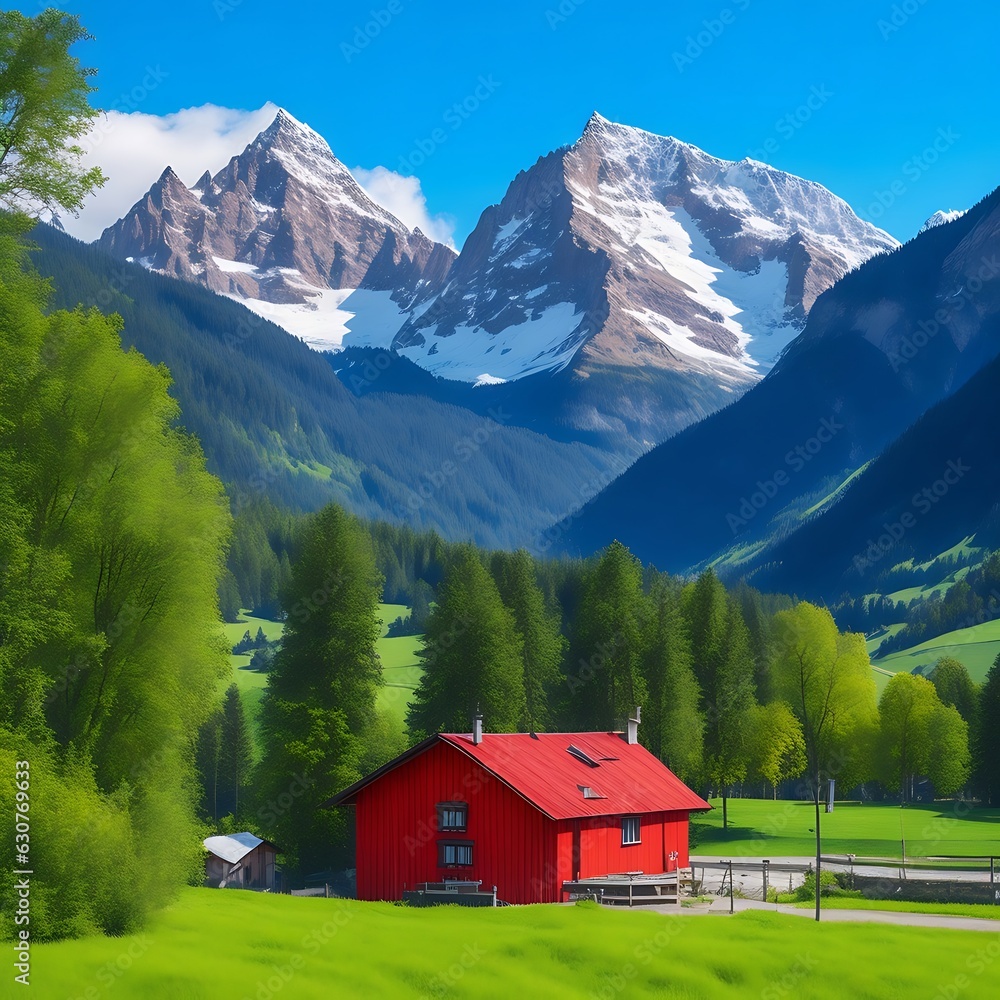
41, 0, 1000, 244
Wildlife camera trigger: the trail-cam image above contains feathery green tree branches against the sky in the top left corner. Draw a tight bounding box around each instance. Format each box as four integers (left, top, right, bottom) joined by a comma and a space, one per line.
0, 9, 104, 211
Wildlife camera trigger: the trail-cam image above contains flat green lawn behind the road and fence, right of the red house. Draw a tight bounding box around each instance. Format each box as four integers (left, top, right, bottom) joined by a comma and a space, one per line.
691, 799, 1000, 858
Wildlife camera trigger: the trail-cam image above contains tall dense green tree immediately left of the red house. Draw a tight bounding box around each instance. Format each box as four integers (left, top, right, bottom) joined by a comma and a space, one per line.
261, 505, 382, 873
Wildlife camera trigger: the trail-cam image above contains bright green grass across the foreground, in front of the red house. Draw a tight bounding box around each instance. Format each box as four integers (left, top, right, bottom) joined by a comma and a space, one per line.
29, 889, 1000, 1000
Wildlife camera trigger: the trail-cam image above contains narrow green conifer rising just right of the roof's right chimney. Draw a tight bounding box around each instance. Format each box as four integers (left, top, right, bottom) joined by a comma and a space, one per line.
639, 583, 705, 781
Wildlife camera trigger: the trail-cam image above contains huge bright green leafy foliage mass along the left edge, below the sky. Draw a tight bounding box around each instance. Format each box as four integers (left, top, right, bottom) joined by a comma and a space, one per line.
0, 225, 229, 938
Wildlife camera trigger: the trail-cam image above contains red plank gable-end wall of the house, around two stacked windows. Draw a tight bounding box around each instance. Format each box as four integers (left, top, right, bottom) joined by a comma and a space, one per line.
355, 743, 562, 903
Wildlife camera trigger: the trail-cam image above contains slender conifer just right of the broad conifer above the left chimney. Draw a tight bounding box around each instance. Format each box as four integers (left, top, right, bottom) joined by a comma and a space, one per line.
492, 549, 566, 731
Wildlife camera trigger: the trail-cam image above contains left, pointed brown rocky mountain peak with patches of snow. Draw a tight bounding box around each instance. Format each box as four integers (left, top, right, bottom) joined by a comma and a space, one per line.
99, 110, 455, 348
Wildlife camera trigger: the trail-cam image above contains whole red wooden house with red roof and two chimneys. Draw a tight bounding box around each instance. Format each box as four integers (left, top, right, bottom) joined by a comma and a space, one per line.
326, 719, 711, 903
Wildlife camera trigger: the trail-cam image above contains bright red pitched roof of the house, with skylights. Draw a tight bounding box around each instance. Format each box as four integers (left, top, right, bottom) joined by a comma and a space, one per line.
326, 733, 712, 820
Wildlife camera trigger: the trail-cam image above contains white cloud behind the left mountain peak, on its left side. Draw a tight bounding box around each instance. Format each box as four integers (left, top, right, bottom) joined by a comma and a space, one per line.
62, 103, 278, 241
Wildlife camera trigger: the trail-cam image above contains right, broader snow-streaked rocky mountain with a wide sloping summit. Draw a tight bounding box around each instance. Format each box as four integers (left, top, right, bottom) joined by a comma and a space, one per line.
392, 114, 898, 387
